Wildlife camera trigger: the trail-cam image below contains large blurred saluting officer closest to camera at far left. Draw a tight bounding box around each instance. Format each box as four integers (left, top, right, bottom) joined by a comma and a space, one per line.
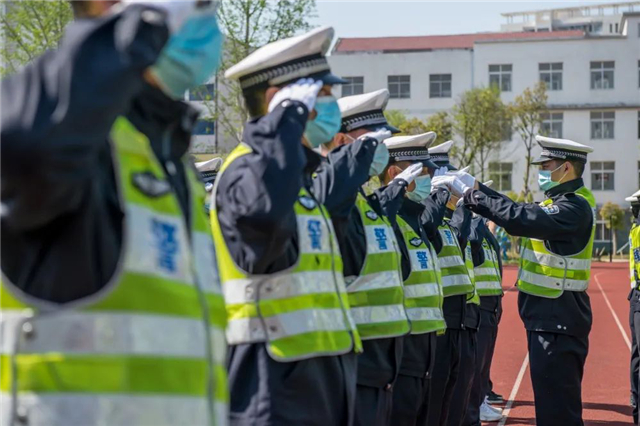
0, 1, 228, 426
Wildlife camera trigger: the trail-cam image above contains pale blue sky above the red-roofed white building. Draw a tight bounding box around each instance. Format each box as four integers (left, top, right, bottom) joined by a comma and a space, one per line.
312, 0, 632, 37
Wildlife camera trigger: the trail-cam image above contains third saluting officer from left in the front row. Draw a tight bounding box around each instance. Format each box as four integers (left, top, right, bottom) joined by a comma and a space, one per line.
322, 89, 412, 426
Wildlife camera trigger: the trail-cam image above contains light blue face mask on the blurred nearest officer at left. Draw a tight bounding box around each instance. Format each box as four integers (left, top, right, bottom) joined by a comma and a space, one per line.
152, 8, 224, 99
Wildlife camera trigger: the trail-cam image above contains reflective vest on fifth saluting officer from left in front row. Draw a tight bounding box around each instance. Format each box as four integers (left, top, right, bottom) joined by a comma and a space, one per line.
438, 219, 474, 297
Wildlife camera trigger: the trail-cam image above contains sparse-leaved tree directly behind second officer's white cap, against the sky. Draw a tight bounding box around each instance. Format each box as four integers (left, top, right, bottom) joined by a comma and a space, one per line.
211, 0, 315, 146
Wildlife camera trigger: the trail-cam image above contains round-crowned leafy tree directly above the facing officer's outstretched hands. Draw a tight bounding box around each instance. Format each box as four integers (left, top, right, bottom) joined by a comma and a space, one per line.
451, 87, 509, 181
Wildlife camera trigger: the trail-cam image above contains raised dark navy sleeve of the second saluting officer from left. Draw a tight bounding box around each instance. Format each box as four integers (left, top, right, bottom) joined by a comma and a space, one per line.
216, 101, 308, 273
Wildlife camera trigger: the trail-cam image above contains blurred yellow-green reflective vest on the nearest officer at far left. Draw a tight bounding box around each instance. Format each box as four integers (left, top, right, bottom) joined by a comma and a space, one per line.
0, 118, 228, 426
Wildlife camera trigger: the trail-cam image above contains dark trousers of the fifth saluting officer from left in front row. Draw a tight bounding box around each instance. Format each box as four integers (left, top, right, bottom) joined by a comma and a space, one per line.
427, 329, 476, 426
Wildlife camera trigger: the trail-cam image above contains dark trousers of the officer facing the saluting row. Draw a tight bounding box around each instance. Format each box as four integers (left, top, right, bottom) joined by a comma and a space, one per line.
527, 331, 589, 426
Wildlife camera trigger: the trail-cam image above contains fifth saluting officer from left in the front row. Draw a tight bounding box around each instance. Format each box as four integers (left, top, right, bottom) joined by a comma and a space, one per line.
428, 141, 484, 426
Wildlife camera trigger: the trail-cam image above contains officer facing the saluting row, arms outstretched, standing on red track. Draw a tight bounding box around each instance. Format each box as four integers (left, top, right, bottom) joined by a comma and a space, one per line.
456, 136, 596, 426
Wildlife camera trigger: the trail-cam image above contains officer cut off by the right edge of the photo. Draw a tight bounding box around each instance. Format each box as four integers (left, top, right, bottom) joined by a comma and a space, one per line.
625, 191, 640, 424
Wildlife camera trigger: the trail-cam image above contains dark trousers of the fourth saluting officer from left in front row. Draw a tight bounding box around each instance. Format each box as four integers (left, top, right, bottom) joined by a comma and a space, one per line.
390, 333, 439, 426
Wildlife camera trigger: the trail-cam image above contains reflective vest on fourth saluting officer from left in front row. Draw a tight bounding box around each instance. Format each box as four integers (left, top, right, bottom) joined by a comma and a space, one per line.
396, 216, 446, 334
